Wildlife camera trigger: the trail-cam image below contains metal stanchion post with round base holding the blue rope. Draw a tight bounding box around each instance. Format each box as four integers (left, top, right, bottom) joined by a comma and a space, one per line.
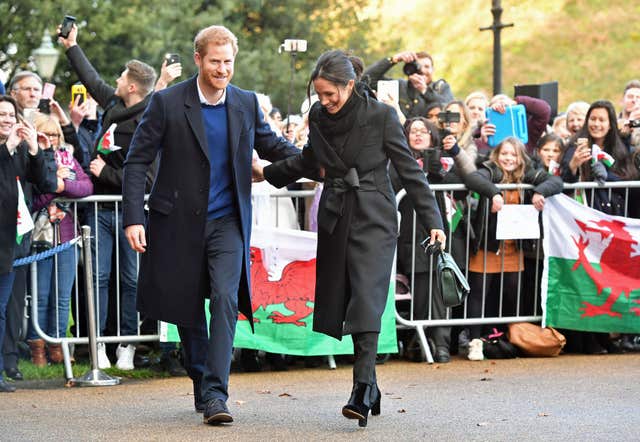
73, 226, 120, 387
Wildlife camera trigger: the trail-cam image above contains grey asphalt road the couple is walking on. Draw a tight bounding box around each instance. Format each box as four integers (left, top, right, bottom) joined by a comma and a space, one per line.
0, 353, 640, 441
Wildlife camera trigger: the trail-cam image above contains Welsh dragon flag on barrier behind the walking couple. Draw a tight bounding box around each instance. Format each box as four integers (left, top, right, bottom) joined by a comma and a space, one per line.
160, 226, 398, 356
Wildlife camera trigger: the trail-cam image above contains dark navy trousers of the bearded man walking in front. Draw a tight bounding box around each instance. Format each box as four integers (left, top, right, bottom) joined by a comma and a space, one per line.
176, 214, 244, 402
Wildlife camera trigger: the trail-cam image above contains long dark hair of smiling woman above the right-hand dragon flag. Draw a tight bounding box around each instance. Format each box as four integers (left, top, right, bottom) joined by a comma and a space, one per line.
572, 100, 634, 180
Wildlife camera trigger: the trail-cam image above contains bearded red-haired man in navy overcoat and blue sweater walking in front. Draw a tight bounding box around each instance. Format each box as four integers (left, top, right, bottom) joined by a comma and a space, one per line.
123, 26, 299, 424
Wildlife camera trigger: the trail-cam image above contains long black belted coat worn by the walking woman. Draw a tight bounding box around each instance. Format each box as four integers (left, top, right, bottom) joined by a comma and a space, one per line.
264, 95, 442, 339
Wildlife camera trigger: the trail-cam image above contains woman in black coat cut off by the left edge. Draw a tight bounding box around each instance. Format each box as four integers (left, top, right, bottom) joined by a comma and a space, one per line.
0, 95, 55, 392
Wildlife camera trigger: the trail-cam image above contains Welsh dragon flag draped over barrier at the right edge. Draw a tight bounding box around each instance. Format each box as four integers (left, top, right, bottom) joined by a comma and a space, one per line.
542, 195, 640, 333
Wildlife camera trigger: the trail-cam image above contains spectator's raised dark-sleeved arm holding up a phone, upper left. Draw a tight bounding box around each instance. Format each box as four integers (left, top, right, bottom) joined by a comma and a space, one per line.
58, 24, 116, 108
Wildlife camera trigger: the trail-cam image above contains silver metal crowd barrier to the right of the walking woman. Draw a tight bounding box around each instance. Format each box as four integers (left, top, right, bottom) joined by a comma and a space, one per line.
396, 181, 640, 363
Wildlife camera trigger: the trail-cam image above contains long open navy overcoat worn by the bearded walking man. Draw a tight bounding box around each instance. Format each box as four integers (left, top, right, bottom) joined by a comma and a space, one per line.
123, 77, 300, 327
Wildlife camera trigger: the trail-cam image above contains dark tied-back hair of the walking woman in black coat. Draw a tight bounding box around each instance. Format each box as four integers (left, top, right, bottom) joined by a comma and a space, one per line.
307, 49, 364, 100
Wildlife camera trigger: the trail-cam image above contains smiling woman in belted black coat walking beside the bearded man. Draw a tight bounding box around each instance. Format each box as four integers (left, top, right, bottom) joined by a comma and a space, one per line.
264, 50, 446, 426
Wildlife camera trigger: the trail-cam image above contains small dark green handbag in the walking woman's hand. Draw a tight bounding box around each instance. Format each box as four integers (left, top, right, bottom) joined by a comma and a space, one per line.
421, 238, 470, 307
